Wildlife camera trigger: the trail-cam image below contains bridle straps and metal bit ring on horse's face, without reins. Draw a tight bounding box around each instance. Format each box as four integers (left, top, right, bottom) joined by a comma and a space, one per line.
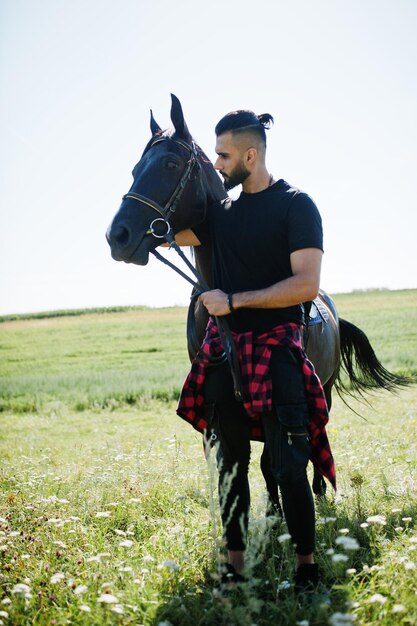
123, 137, 200, 239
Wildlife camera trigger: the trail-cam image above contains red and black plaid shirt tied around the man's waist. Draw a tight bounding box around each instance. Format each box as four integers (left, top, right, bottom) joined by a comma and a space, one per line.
177, 318, 336, 489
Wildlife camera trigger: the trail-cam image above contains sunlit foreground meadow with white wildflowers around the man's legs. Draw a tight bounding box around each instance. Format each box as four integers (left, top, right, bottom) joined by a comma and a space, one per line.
0, 390, 417, 626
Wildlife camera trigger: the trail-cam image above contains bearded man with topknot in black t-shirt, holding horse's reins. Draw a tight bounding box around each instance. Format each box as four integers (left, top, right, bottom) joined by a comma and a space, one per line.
176, 111, 335, 591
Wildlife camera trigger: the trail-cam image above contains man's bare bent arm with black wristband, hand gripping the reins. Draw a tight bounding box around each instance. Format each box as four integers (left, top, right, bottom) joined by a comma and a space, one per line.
200, 248, 323, 315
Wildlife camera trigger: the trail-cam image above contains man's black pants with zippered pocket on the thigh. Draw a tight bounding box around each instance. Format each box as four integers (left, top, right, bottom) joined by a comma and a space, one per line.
205, 347, 315, 555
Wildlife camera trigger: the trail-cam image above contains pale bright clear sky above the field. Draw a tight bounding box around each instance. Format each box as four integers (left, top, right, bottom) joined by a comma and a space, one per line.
0, 0, 417, 313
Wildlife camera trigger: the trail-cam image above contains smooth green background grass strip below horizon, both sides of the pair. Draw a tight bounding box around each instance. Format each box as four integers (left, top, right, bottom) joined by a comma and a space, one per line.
0, 290, 417, 414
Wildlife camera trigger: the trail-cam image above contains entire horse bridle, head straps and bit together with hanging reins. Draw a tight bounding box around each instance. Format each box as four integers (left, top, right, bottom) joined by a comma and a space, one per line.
123, 137, 243, 402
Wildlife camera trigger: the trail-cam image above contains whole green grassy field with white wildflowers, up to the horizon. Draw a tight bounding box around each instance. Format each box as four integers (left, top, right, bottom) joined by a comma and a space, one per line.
0, 290, 417, 626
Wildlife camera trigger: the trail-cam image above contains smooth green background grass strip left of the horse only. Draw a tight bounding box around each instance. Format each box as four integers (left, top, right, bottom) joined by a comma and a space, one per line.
0, 308, 188, 413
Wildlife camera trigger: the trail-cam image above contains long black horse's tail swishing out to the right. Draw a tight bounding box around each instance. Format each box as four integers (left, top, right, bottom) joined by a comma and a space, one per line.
335, 318, 415, 396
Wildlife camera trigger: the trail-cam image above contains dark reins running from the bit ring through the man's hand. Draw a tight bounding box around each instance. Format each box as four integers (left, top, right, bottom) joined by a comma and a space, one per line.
151, 229, 243, 402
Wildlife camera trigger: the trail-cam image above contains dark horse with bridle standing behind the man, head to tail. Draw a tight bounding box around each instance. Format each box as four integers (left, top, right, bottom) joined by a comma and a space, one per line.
106, 94, 410, 510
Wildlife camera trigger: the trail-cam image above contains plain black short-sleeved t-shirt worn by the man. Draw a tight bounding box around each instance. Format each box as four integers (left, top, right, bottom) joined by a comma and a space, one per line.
193, 179, 323, 334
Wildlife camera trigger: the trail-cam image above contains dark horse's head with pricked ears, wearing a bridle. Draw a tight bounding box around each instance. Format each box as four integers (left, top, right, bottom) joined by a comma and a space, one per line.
106, 95, 225, 265
